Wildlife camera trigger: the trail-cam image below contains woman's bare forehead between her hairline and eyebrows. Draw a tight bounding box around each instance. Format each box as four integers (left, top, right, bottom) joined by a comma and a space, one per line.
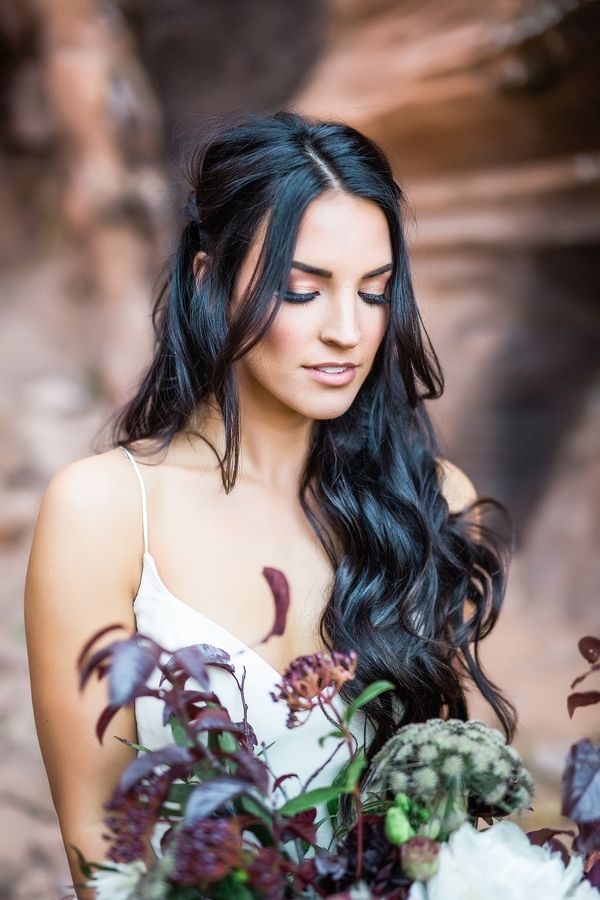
294, 191, 392, 272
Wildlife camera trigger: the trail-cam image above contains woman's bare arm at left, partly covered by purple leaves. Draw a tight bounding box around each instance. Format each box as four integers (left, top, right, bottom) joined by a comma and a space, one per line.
25, 453, 141, 900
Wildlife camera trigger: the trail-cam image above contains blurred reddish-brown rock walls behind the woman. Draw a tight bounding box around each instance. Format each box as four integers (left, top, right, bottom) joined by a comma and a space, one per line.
0, 0, 600, 900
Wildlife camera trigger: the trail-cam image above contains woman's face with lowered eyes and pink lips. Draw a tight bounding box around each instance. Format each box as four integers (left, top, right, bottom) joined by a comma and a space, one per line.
232, 191, 392, 419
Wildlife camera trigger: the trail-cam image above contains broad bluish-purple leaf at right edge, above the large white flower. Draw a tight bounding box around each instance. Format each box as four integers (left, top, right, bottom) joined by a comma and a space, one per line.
561, 738, 600, 824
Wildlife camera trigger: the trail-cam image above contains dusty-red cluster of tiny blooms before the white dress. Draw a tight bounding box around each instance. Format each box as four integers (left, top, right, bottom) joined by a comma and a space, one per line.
271, 650, 357, 728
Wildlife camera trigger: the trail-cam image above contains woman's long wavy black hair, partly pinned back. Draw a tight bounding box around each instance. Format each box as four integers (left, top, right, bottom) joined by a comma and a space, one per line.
103, 110, 516, 756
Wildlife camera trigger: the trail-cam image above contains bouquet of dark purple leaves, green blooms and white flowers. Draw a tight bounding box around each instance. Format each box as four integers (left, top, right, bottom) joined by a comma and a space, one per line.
75, 569, 600, 900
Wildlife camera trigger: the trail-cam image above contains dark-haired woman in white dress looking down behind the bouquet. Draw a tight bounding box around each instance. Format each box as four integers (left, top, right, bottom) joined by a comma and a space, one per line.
25, 111, 515, 897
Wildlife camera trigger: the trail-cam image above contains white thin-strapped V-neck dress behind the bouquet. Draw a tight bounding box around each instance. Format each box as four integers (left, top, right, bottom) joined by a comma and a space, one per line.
121, 447, 373, 855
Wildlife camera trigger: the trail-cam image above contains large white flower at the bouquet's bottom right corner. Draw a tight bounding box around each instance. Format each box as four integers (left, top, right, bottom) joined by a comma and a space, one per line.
408, 821, 600, 900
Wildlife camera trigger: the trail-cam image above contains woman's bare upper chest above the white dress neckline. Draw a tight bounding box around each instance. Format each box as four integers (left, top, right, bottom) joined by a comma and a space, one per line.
150, 474, 333, 672
